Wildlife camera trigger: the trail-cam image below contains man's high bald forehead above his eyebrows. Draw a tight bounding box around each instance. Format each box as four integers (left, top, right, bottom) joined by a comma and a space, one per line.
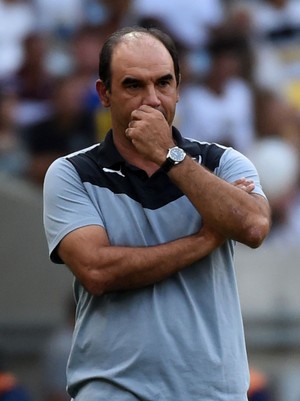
111, 33, 174, 76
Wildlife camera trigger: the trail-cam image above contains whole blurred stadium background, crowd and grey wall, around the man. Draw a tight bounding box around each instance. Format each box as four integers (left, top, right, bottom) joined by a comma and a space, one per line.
0, 0, 300, 401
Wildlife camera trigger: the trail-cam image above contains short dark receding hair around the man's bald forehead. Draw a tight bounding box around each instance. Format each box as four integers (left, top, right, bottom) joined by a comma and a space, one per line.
99, 26, 180, 91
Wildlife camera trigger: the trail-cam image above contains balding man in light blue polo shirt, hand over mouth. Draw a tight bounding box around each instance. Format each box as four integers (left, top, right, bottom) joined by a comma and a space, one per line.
44, 28, 270, 401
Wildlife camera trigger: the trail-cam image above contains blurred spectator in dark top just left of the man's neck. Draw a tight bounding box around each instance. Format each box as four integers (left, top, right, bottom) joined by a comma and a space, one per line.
25, 75, 96, 184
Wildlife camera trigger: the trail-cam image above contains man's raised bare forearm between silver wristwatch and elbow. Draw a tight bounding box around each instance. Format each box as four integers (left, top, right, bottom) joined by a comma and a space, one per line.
168, 157, 269, 247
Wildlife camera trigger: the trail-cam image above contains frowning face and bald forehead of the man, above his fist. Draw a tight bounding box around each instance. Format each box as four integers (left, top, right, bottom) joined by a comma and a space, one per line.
101, 34, 178, 133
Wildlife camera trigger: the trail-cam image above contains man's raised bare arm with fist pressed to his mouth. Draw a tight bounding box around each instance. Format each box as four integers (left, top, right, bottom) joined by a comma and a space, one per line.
126, 106, 270, 247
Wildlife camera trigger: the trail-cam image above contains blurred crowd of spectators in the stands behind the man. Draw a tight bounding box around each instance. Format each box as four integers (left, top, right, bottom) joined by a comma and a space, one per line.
0, 0, 300, 401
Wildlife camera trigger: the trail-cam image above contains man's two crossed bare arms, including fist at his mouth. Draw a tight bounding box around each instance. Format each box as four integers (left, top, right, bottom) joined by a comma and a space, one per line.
58, 108, 270, 295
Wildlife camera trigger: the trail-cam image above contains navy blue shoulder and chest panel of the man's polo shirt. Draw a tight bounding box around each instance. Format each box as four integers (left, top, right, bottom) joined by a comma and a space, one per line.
67, 138, 225, 209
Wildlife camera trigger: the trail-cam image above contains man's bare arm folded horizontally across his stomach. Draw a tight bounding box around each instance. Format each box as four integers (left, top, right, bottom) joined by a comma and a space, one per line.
58, 222, 224, 295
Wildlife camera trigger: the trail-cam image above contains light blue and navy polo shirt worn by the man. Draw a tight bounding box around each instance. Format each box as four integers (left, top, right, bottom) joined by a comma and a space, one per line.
44, 128, 264, 401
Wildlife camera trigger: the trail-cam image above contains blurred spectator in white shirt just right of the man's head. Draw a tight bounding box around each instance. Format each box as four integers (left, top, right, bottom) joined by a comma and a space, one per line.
176, 36, 255, 152
